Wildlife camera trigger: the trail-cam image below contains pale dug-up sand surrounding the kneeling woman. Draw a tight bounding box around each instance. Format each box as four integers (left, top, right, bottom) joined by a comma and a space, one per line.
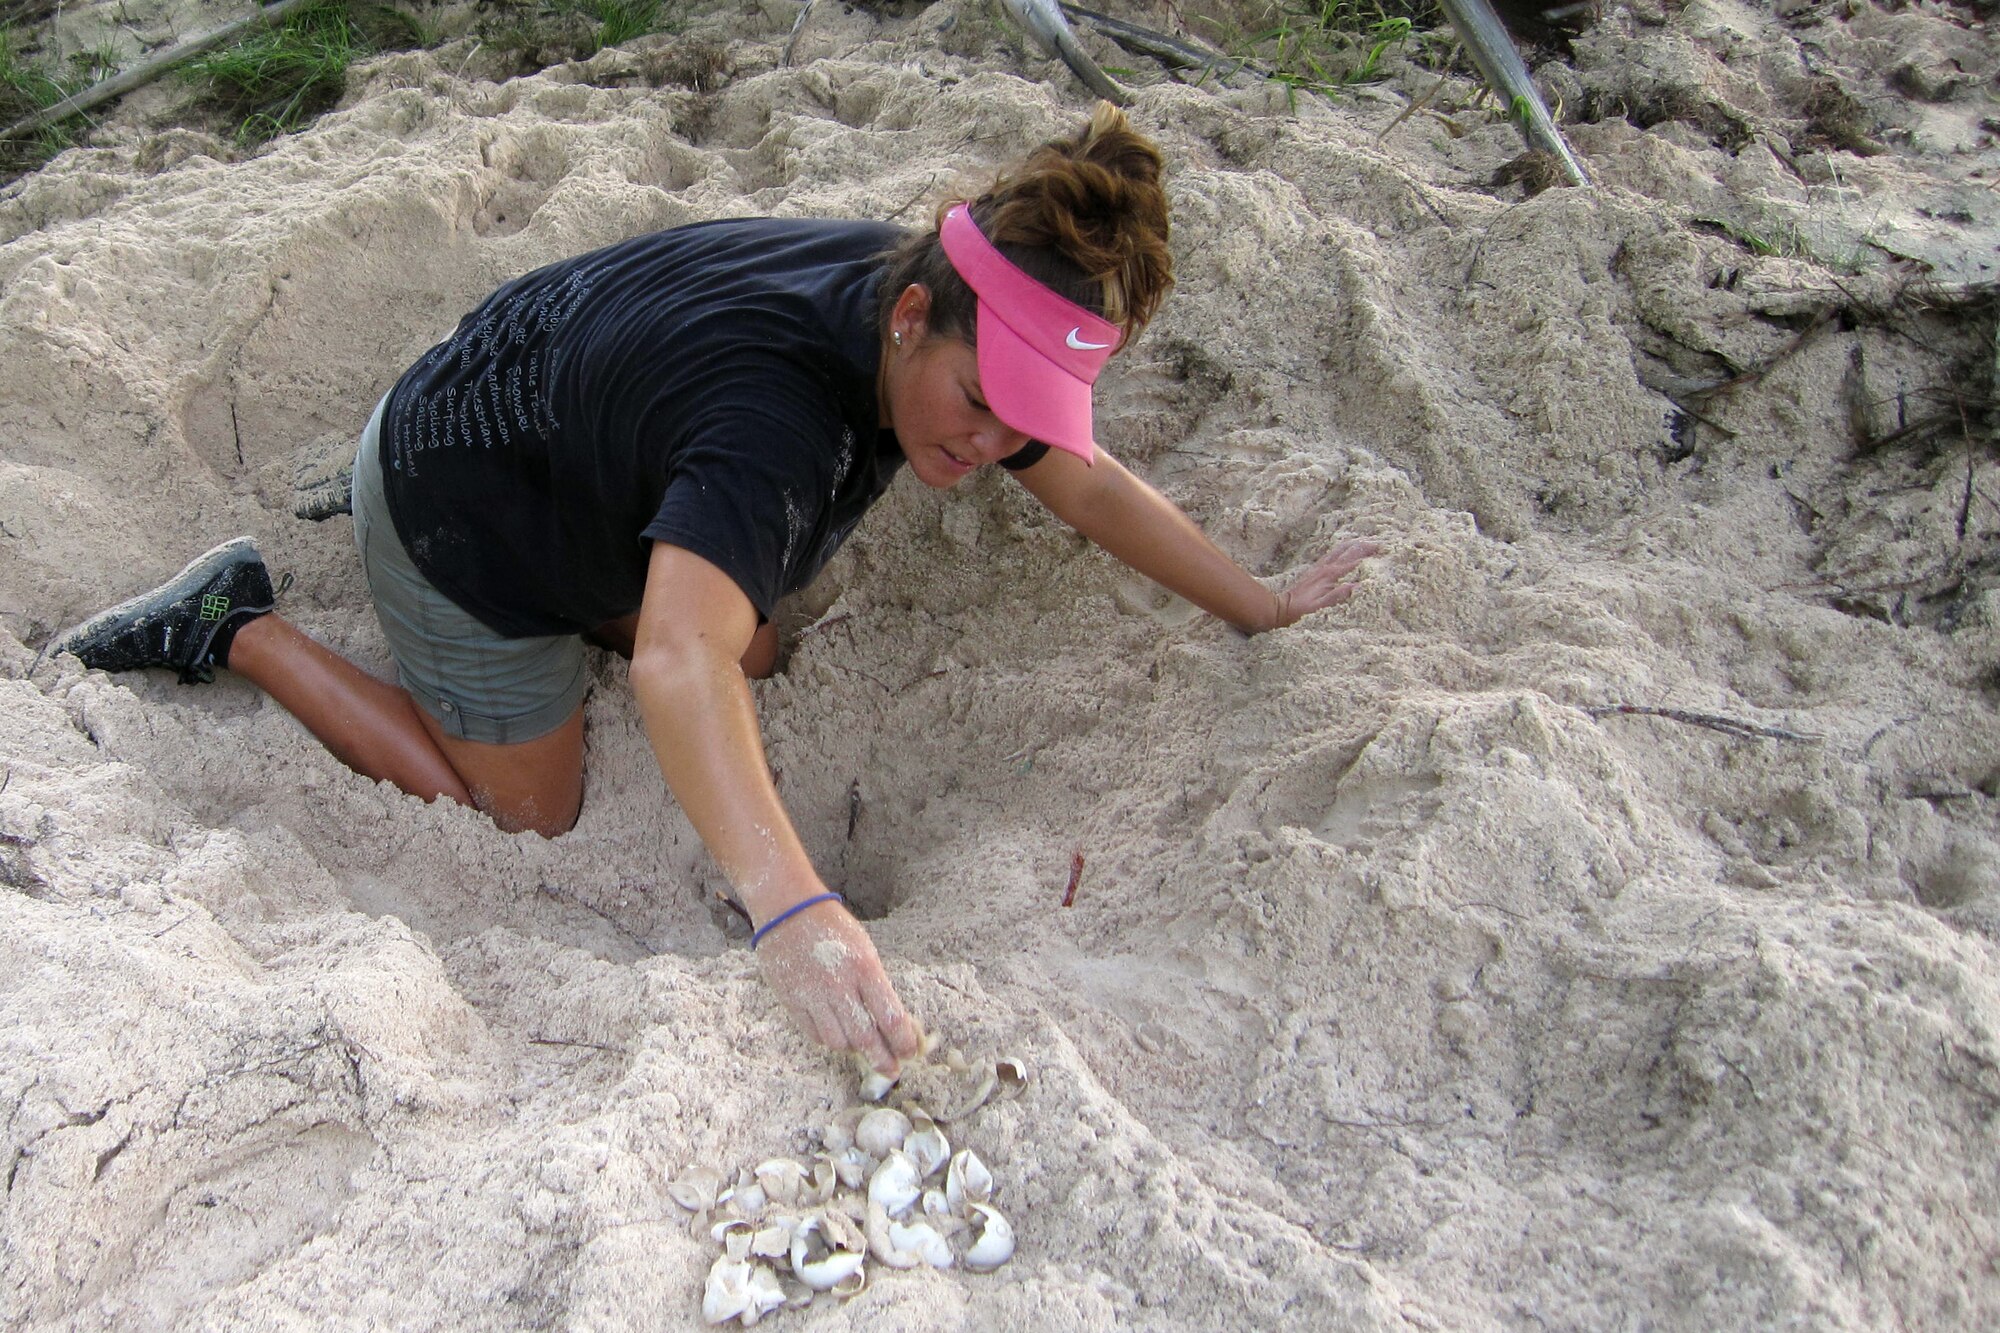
0, 0, 2000, 1329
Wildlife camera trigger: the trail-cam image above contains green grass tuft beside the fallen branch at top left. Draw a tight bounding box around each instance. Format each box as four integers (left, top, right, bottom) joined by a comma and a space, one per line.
180, 2, 372, 146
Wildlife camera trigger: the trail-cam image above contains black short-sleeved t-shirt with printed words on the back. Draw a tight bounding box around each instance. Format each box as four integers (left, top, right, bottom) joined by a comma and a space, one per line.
382, 218, 916, 636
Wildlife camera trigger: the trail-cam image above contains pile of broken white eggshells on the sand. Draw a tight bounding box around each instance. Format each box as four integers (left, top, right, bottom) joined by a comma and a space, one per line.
668, 1051, 1026, 1327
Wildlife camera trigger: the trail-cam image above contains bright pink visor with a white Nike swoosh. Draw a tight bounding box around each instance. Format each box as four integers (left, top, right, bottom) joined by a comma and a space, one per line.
938, 204, 1124, 462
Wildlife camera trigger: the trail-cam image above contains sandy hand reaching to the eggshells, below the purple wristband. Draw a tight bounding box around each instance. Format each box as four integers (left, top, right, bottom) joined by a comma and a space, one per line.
756, 901, 918, 1077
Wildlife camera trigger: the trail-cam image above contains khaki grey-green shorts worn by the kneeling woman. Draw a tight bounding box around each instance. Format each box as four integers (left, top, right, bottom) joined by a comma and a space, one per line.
354, 398, 590, 745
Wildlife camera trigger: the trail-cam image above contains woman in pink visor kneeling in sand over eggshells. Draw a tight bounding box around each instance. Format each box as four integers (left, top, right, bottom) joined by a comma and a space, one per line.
54, 104, 1374, 1073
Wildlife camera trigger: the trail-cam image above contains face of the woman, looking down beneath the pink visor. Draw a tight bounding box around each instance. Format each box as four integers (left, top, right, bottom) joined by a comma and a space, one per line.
882, 288, 1028, 490
